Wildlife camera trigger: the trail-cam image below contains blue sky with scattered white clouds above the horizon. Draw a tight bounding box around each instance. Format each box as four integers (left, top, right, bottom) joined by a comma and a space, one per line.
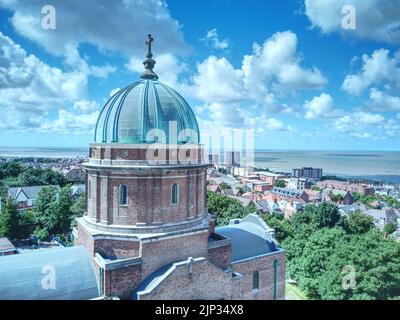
0, 0, 400, 151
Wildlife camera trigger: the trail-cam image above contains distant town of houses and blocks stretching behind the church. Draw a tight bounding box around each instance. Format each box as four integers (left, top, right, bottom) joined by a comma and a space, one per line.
0, 151, 400, 248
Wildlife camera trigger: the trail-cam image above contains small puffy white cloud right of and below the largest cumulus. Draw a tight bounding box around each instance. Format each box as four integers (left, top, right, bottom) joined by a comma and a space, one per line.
304, 93, 342, 119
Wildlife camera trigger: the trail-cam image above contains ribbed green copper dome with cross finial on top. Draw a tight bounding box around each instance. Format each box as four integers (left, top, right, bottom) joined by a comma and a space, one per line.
94, 35, 200, 144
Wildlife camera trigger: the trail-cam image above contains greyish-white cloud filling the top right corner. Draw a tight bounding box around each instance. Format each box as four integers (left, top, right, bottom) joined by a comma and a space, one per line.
305, 0, 400, 44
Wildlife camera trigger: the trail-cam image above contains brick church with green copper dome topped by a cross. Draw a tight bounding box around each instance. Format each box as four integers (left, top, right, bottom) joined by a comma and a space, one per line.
0, 35, 286, 300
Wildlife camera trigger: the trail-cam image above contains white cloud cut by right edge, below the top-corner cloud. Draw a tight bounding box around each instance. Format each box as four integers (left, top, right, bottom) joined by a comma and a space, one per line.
342, 49, 400, 95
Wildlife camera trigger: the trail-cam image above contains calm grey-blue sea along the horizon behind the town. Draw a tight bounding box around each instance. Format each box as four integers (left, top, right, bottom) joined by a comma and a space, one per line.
0, 147, 400, 184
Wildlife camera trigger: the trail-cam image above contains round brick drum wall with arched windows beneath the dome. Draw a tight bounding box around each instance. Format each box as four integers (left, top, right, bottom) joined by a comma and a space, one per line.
87, 168, 206, 225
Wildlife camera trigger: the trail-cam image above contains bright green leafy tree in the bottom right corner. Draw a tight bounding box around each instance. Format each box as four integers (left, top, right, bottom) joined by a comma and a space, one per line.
318, 229, 400, 300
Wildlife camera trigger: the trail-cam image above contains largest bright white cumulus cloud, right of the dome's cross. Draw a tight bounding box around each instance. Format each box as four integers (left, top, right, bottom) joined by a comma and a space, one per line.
192, 31, 327, 107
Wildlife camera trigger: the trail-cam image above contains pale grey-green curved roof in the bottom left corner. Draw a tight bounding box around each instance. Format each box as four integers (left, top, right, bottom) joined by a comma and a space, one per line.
0, 246, 99, 300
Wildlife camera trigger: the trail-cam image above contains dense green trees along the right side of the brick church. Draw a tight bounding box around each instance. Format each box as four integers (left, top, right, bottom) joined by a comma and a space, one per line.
207, 192, 400, 300
